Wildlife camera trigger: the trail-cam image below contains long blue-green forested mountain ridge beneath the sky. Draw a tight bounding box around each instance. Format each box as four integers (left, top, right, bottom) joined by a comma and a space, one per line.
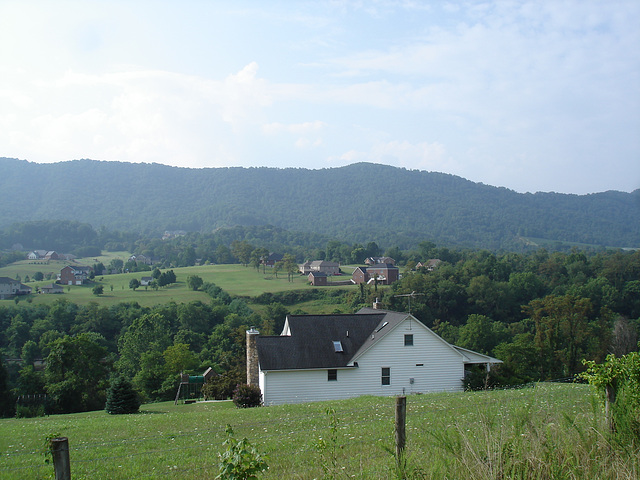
0, 158, 640, 250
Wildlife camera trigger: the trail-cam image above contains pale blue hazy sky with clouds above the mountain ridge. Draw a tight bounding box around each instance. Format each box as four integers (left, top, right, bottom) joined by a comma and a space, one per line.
0, 0, 640, 194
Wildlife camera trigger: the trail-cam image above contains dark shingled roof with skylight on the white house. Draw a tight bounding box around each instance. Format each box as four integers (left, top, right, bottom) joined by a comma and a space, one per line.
256, 310, 388, 371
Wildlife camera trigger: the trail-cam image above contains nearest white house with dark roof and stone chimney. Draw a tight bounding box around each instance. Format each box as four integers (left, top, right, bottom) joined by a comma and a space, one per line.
247, 308, 502, 405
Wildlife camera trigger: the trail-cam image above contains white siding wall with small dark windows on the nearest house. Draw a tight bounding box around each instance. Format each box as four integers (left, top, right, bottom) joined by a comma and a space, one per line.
260, 320, 464, 405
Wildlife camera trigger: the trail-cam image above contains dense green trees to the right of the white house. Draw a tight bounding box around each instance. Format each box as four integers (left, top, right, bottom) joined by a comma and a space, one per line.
378, 250, 640, 384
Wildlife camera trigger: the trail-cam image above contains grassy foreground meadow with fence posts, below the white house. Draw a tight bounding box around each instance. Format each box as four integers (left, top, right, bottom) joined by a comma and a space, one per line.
0, 384, 640, 480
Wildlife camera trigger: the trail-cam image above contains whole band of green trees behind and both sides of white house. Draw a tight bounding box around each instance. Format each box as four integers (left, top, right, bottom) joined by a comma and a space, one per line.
0, 242, 640, 412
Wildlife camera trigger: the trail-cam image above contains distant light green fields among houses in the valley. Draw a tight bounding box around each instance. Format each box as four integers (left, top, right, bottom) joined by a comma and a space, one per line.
0, 258, 356, 313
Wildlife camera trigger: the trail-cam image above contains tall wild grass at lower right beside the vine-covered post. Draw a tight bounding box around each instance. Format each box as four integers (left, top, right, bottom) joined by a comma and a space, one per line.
420, 388, 640, 479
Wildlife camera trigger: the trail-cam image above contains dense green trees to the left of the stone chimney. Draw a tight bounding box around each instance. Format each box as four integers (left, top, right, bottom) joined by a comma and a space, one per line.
0, 279, 298, 415
